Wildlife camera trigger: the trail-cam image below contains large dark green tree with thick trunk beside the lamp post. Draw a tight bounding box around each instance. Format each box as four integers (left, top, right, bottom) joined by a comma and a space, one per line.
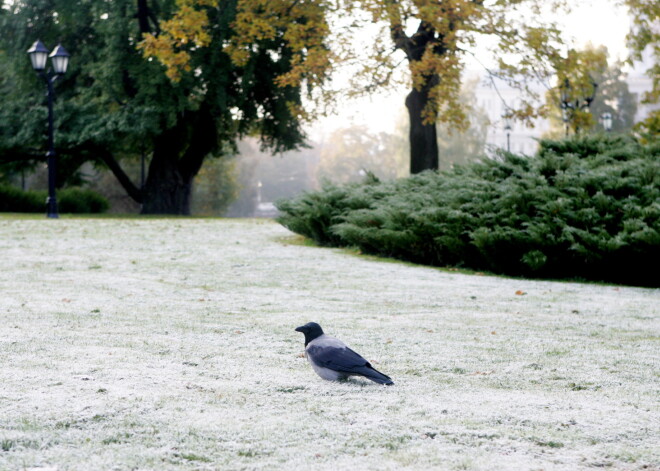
0, 0, 323, 214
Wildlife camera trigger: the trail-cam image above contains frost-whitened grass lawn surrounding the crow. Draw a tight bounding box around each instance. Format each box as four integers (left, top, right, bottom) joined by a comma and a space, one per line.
0, 216, 660, 471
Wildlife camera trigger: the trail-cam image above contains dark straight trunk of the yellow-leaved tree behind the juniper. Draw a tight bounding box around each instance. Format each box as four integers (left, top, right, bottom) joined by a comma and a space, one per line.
406, 81, 438, 174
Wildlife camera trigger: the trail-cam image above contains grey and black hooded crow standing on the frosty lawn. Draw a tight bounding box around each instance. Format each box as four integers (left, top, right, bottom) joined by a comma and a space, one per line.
296, 322, 394, 386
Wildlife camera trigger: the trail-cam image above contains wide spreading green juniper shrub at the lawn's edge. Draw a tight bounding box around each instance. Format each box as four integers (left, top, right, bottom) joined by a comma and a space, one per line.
278, 136, 660, 286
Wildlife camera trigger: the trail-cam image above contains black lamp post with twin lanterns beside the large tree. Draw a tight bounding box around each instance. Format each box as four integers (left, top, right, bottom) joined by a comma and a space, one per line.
27, 40, 69, 218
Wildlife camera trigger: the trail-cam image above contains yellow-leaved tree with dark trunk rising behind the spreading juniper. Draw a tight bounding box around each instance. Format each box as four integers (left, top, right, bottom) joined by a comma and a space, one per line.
348, 0, 584, 173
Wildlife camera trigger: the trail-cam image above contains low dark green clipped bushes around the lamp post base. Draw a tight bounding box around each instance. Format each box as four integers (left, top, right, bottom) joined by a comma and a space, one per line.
0, 185, 109, 213
